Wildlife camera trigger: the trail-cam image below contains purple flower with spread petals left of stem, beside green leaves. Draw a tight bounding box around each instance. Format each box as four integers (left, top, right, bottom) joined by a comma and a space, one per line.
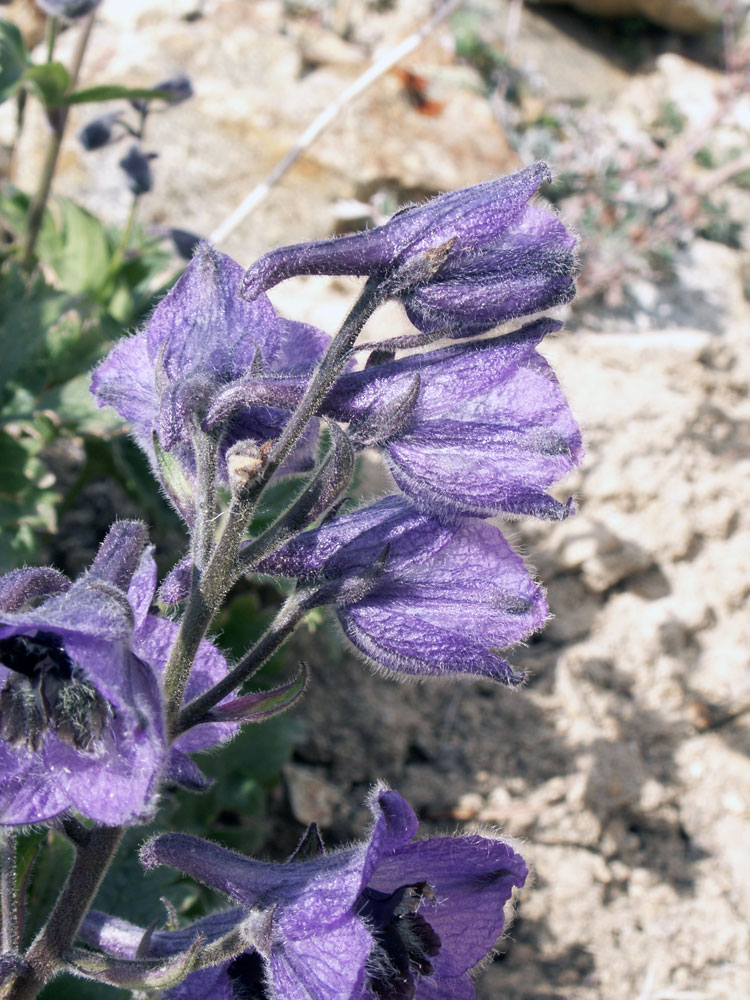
92, 244, 329, 520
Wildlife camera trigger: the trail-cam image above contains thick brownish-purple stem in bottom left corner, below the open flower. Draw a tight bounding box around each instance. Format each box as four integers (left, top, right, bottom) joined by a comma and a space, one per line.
0, 826, 124, 1000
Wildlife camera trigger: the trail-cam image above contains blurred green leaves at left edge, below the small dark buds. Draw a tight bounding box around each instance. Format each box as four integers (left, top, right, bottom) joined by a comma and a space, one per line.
0, 189, 176, 571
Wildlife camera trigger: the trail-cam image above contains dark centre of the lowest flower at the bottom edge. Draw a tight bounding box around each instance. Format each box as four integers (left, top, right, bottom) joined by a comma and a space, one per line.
357, 882, 441, 1000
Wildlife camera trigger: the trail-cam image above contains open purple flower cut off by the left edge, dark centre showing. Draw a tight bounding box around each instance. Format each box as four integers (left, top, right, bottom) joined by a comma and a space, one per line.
0, 521, 236, 825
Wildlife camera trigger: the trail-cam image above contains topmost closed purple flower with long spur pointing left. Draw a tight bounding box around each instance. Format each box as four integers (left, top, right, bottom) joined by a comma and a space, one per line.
243, 163, 576, 337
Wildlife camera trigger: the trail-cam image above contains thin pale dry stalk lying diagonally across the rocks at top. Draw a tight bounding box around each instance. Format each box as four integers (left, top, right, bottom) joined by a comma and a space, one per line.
209, 0, 464, 246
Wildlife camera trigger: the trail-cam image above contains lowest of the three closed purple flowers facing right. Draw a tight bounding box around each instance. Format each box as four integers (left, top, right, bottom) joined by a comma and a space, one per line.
255, 497, 547, 684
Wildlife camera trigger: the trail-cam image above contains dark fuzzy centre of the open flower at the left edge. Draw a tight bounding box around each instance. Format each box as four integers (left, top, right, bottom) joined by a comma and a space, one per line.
0, 632, 114, 753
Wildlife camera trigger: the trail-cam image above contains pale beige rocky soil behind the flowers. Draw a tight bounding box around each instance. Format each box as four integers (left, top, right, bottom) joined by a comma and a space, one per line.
0, 0, 750, 1000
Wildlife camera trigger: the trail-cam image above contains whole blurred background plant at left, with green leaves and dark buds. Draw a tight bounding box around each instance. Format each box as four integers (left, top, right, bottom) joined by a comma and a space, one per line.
0, 13, 196, 573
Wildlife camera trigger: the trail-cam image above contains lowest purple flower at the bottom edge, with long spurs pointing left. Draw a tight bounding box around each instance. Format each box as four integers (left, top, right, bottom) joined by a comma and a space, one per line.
83, 786, 527, 1000
